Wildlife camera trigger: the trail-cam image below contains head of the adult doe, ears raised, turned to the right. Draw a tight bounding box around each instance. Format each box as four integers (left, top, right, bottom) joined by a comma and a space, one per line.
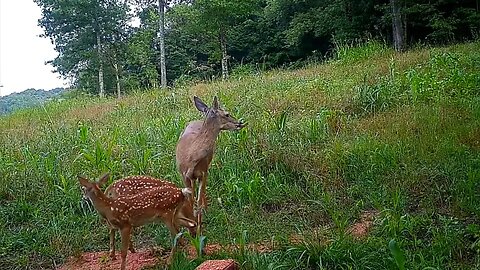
193, 96, 246, 130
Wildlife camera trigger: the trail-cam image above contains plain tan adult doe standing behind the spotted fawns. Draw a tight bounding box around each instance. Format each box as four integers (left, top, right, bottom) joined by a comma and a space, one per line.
176, 96, 245, 228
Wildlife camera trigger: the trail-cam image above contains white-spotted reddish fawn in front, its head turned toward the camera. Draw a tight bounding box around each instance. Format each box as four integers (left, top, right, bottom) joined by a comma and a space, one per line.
78, 174, 197, 270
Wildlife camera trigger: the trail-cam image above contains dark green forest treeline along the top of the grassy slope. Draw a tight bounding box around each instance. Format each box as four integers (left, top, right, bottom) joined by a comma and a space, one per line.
34, 0, 480, 96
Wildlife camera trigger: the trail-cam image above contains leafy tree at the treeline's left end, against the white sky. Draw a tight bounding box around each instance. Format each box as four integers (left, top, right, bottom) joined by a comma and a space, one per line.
35, 0, 127, 96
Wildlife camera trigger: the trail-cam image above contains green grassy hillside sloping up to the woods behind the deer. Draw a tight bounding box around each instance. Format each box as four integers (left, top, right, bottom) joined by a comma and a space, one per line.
0, 42, 480, 269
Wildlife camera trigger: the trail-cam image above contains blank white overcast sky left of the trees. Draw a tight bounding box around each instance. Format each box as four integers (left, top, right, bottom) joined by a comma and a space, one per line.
0, 0, 66, 96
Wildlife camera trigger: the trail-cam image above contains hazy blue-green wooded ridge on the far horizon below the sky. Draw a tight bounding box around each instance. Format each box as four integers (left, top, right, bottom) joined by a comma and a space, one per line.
0, 87, 66, 115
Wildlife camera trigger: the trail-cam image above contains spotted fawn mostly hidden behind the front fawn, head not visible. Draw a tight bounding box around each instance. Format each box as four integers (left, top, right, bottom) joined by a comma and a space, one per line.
105, 175, 196, 259
